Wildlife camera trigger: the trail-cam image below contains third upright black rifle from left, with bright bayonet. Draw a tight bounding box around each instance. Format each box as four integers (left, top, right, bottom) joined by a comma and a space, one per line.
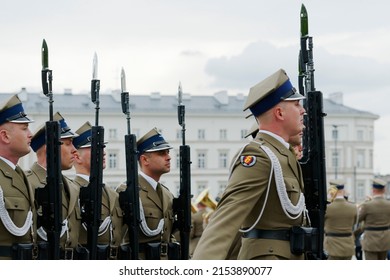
119, 68, 140, 260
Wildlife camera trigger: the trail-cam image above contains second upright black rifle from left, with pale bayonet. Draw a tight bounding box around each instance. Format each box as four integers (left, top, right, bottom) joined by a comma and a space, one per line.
80, 53, 107, 260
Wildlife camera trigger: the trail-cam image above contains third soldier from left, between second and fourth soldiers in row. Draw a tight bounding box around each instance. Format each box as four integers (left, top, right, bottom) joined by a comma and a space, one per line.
73, 122, 122, 259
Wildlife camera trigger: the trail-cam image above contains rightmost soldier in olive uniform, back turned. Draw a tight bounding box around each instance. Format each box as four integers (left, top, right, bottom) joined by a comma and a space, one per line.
359, 179, 390, 260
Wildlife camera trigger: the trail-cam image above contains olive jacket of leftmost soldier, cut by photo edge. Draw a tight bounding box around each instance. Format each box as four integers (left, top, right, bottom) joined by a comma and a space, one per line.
0, 159, 36, 259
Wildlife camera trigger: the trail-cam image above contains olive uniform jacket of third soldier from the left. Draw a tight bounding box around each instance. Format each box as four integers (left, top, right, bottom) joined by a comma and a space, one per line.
73, 175, 123, 248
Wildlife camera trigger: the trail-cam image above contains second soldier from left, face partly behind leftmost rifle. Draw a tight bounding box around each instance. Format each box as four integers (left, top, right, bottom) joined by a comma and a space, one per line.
26, 112, 88, 259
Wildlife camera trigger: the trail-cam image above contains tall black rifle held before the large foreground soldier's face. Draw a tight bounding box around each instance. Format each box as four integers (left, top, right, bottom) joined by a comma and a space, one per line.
298, 4, 327, 259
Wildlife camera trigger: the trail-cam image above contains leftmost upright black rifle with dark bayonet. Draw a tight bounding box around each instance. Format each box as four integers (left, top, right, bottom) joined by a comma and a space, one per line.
36, 39, 63, 260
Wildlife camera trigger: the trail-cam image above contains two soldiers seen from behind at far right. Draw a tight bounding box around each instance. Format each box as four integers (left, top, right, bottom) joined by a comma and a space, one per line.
324, 179, 390, 260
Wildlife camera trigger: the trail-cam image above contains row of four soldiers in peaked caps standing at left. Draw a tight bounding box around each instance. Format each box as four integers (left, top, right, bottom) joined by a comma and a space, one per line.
0, 95, 179, 259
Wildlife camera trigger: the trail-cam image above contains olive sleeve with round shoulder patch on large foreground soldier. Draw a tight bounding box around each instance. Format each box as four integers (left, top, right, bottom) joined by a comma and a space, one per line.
193, 146, 271, 260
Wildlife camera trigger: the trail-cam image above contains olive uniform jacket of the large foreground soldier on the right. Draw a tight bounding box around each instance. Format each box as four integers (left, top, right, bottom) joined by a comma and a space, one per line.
193, 133, 303, 260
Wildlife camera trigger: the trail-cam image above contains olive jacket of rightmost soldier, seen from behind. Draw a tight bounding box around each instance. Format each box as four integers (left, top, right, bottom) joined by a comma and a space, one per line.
359, 197, 390, 252
